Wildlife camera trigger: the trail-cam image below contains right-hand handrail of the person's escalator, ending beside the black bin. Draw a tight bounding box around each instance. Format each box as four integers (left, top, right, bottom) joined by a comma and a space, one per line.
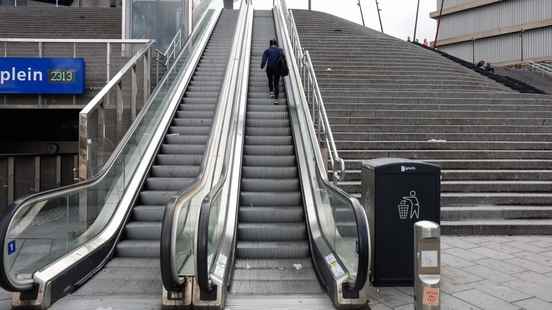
274, 0, 372, 296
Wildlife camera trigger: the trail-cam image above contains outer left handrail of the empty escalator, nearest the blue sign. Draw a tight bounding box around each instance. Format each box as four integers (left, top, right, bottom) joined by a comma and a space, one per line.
0, 7, 217, 291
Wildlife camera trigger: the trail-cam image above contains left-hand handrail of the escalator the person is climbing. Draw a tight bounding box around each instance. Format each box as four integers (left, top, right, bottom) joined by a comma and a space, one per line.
196, 0, 253, 293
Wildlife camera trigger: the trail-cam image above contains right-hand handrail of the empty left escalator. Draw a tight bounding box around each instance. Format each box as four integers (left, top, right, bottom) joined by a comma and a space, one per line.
160, 3, 249, 291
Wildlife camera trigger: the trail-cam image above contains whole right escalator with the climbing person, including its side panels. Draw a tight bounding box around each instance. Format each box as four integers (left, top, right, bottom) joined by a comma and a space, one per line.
161, 0, 371, 309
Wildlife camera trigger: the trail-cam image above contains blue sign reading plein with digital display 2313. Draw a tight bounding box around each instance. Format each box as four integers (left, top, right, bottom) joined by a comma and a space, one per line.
0, 57, 85, 95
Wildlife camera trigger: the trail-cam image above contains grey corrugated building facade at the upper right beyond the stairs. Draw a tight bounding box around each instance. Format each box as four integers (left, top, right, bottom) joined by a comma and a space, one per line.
431, 0, 552, 65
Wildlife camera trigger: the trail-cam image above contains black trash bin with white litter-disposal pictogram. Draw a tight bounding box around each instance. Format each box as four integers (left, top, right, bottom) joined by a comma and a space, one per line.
361, 158, 441, 286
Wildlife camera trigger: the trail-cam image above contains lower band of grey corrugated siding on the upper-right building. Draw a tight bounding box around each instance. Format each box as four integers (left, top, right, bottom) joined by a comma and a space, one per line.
440, 27, 552, 63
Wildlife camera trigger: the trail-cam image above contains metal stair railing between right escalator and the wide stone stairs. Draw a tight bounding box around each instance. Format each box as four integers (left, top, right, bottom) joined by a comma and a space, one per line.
286, 10, 345, 182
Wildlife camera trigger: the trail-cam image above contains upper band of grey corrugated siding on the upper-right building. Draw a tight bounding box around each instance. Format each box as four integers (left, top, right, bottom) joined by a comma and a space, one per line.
439, 0, 552, 39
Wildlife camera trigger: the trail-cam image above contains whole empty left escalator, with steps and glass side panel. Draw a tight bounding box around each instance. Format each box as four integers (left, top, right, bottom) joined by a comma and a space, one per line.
0, 2, 238, 309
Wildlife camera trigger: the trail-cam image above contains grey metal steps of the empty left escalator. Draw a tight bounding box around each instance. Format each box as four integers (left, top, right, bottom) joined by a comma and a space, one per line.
52, 10, 238, 309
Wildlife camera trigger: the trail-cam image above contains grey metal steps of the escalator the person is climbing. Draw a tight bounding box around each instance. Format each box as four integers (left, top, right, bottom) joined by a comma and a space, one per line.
231, 11, 322, 295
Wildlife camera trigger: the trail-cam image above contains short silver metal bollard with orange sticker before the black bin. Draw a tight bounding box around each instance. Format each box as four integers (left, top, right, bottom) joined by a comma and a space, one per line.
414, 221, 441, 310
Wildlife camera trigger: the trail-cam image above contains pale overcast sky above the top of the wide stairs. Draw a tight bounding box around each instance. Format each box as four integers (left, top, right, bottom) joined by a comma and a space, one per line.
253, 0, 437, 42
